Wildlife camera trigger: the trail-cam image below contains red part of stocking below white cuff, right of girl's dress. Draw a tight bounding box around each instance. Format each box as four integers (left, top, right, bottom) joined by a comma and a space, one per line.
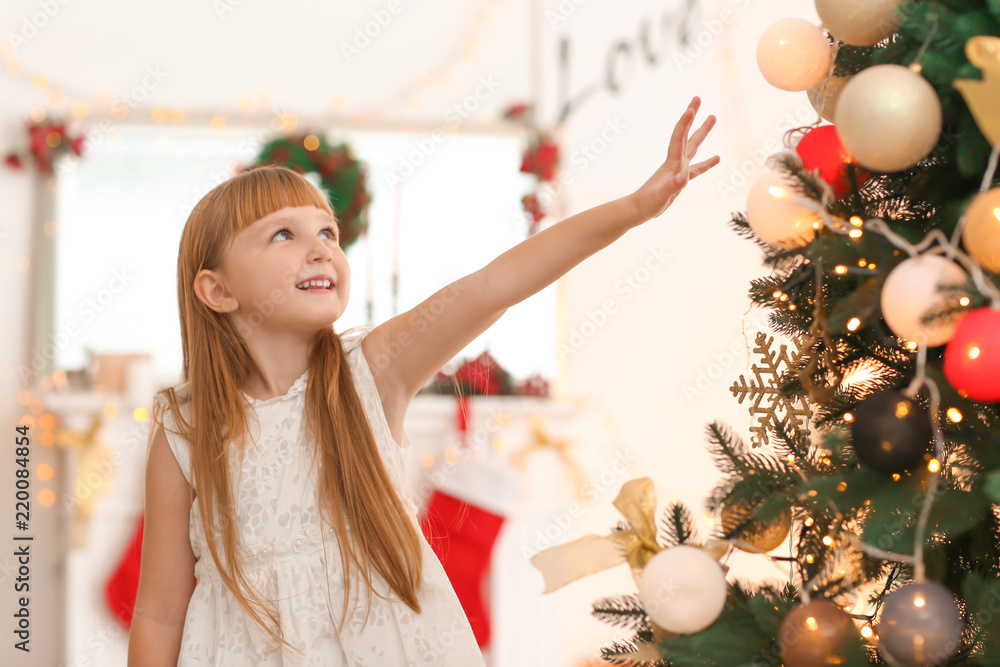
420, 489, 504, 648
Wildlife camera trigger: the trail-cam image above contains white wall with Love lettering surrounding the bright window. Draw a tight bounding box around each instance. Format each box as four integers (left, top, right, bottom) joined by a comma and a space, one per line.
0, 0, 815, 665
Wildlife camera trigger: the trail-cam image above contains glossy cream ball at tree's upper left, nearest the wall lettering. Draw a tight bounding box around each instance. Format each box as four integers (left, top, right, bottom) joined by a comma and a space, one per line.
757, 18, 833, 91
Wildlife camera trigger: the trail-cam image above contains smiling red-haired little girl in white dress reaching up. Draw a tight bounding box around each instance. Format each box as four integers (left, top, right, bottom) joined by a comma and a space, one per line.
128, 97, 719, 667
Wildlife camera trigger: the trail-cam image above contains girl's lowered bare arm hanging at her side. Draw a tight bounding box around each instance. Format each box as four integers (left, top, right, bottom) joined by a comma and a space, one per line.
128, 423, 196, 667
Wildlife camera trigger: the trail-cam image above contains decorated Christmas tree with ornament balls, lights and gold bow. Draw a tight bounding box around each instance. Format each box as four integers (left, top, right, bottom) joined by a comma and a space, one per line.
533, 0, 1000, 667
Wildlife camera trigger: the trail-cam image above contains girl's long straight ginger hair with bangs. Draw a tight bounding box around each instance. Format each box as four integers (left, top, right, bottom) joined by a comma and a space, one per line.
153, 166, 422, 650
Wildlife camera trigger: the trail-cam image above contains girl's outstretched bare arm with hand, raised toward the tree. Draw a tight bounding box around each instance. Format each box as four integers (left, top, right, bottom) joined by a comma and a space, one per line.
365, 97, 719, 405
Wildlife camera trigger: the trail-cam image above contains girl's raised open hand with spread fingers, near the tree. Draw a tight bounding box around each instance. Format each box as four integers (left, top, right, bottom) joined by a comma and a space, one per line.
630, 97, 719, 222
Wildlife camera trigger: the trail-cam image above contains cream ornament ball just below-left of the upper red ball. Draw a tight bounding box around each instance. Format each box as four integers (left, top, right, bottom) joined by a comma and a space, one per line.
747, 171, 821, 250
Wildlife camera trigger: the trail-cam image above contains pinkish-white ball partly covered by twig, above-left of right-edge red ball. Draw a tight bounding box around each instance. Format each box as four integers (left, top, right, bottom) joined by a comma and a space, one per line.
881, 255, 968, 347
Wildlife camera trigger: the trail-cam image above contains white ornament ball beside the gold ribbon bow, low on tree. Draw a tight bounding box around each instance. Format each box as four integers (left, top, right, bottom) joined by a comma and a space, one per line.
639, 545, 726, 635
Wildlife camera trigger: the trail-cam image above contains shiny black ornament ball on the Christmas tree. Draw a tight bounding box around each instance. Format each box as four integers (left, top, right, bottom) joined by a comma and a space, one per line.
851, 389, 934, 474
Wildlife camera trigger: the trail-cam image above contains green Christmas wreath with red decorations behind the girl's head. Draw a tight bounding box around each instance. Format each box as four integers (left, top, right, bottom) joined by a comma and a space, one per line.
252, 134, 372, 250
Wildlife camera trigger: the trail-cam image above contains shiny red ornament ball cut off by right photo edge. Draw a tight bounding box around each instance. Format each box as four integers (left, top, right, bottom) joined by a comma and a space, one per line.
944, 307, 1000, 403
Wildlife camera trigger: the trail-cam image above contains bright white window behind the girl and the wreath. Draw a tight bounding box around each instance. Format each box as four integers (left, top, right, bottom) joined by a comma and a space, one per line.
54, 128, 557, 384
